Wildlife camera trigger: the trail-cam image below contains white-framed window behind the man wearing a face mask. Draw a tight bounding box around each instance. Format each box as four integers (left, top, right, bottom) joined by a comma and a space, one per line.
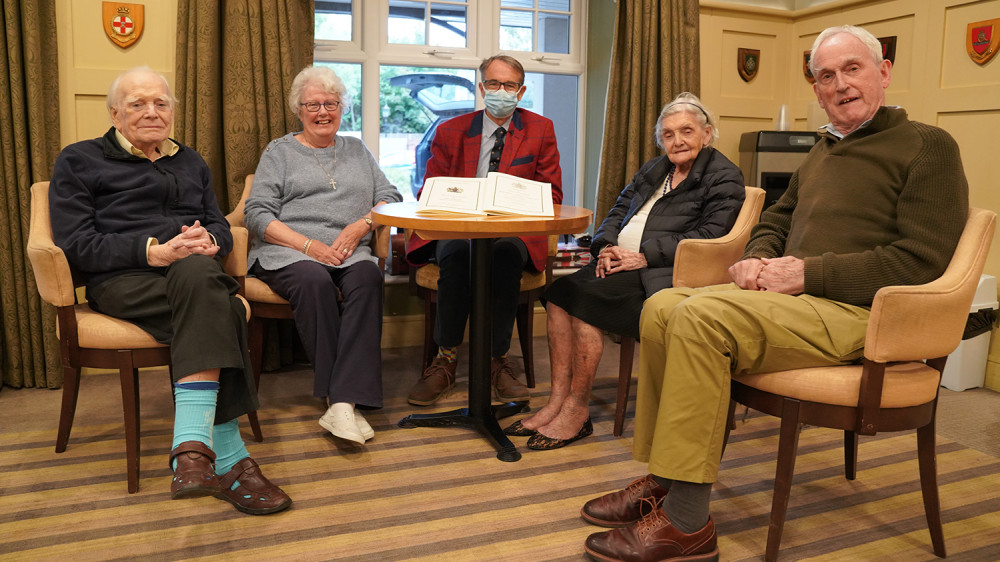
314, 0, 586, 204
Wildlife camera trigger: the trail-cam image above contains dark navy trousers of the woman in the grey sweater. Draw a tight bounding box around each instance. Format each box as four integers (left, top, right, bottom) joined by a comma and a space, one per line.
252, 260, 384, 408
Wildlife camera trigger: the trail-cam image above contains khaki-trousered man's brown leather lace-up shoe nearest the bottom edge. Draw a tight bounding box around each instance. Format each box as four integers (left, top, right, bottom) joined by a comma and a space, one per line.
584, 500, 719, 562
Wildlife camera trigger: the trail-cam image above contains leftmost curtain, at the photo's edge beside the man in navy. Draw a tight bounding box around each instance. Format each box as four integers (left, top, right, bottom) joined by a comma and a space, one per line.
0, 0, 62, 388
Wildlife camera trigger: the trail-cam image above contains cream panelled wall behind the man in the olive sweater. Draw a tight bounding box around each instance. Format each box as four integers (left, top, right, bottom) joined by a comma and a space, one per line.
701, 0, 1000, 390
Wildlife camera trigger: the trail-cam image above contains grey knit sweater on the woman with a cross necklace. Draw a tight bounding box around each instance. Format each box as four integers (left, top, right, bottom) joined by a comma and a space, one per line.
244, 133, 403, 270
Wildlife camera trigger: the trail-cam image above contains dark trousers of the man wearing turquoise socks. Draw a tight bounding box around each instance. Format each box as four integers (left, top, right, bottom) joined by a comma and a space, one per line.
87, 255, 258, 424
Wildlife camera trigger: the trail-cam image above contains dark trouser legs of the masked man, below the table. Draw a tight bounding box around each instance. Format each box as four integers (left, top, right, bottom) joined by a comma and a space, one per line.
434, 237, 528, 357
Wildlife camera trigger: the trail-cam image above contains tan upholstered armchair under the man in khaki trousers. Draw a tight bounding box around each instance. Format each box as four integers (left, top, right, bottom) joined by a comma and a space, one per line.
726, 209, 996, 560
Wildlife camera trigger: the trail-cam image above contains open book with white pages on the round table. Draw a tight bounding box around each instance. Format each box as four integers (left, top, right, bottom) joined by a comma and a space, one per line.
417, 172, 555, 217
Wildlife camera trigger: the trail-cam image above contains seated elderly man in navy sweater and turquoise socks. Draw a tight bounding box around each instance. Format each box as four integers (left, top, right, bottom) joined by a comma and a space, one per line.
49, 67, 292, 515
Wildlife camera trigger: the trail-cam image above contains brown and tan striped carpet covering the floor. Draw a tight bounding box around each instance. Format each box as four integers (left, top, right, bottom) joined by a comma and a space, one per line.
0, 372, 1000, 561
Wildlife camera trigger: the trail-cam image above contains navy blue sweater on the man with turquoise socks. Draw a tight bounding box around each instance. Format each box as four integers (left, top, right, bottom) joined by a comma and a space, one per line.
49, 128, 233, 286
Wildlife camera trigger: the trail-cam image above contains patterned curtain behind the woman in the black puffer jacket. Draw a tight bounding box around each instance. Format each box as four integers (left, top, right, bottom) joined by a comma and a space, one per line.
595, 0, 701, 225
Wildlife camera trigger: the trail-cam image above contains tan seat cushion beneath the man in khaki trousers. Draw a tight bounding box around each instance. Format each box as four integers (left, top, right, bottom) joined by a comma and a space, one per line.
735, 362, 941, 408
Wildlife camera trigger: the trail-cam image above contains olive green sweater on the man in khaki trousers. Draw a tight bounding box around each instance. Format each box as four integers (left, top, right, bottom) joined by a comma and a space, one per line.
743, 107, 969, 306
